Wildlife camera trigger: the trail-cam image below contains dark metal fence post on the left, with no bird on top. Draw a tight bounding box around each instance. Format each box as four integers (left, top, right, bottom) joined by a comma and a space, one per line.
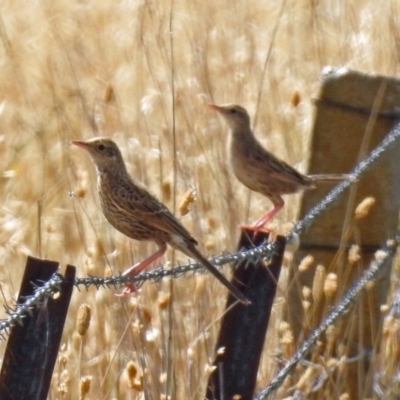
0, 257, 75, 400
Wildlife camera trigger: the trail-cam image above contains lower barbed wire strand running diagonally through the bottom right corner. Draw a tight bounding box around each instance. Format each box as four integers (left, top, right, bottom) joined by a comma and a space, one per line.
254, 236, 399, 400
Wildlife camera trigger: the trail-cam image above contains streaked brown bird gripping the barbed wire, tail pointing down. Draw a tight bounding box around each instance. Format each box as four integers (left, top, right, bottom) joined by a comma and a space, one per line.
71, 137, 248, 303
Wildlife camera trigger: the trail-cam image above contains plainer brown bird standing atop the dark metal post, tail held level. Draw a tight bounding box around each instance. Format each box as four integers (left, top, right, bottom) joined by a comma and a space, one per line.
208, 104, 352, 231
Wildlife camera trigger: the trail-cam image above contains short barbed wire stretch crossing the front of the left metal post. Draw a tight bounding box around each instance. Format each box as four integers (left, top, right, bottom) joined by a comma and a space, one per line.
0, 273, 63, 339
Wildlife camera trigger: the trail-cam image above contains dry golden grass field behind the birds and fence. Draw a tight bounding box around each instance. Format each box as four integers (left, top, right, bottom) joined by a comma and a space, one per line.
0, 0, 400, 400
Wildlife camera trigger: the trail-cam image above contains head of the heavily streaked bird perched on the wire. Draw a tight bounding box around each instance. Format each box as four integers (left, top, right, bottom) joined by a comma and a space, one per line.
71, 137, 126, 173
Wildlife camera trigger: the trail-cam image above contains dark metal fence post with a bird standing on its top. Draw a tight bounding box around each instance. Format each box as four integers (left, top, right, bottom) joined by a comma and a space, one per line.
206, 231, 285, 400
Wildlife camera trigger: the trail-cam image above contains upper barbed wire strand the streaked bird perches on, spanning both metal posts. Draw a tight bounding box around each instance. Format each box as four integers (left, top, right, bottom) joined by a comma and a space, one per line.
0, 119, 400, 344
